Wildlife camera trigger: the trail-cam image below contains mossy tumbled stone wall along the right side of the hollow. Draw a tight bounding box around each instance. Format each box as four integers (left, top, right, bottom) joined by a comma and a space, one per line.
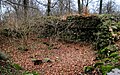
84, 15, 120, 75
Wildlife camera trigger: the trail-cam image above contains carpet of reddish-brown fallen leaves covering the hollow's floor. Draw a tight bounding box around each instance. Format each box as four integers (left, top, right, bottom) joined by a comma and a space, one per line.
1, 35, 96, 75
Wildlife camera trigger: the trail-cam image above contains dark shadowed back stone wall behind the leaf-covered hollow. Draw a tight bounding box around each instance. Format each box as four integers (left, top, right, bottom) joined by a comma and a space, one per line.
39, 16, 101, 42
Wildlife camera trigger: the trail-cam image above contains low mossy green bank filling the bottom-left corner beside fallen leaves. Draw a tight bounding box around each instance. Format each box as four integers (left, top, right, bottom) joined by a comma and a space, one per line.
0, 60, 39, 75
